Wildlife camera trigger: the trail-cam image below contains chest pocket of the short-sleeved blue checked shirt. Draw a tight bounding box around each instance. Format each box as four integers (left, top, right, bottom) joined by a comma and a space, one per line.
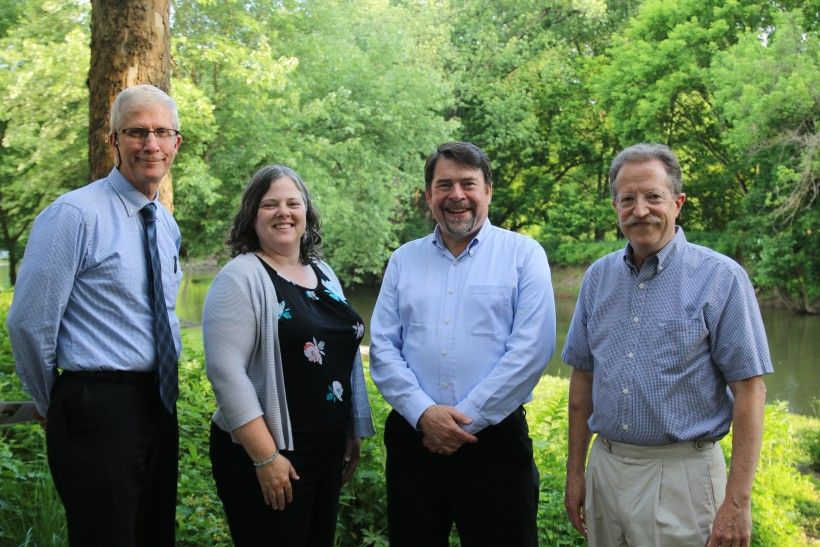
652, 318, 709, 368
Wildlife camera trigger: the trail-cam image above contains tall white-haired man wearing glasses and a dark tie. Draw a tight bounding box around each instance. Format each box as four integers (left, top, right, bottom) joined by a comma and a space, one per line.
8, 85, 182, 547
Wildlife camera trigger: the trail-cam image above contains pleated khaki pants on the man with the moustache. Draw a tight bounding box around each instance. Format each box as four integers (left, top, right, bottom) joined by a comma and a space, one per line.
584, 436, 726, 547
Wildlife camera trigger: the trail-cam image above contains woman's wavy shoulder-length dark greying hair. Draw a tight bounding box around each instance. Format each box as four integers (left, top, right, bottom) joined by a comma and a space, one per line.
226, 165, 322, 264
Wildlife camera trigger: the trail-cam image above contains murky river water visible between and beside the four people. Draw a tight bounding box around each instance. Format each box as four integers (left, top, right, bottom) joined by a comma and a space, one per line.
177, 275, 820, 416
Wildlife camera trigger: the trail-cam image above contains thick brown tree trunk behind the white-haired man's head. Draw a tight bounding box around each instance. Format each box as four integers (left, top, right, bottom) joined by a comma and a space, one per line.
88, 0, 173, 210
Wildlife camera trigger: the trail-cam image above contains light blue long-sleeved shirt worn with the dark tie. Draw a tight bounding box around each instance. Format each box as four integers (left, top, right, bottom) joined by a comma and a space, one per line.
8, 168, 182, 416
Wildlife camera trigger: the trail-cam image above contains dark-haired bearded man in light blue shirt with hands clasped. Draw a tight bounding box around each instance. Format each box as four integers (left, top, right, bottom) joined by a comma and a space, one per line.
370, 142, 555, 547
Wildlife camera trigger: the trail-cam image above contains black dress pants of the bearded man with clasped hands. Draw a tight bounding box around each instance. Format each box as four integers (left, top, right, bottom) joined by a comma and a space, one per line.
384, 408, 538, 547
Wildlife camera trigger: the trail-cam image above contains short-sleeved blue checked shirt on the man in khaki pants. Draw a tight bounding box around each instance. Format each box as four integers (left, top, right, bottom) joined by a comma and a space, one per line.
562, 227, 773, 446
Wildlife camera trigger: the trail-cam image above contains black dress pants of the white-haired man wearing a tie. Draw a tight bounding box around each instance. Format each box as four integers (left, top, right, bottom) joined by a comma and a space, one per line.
46, 372, 179, 547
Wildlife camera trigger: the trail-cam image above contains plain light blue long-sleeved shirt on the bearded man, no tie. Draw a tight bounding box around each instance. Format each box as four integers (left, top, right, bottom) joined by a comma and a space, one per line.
370, 220, 555, 433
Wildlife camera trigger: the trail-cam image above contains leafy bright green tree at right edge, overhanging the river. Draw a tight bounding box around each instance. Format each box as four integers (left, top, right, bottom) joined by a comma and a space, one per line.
711, 10, 820, 311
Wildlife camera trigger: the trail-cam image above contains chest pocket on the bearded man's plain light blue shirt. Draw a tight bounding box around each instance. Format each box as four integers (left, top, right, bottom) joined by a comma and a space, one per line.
463, 285, 514, 336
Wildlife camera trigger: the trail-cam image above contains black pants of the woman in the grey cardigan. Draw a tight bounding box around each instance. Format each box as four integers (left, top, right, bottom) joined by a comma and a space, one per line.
210, 422, 347, 547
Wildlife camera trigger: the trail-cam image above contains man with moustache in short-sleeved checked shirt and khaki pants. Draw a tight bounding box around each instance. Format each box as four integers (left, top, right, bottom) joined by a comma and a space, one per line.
562, 143, 773, 547
